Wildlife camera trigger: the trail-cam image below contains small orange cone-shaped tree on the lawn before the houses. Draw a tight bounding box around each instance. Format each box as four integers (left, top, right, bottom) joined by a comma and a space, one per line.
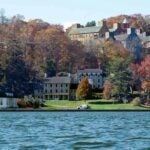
76, 77, 92, 100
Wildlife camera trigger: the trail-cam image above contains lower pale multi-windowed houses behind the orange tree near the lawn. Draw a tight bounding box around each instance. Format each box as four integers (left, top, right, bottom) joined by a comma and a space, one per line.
34, 69, 105, 100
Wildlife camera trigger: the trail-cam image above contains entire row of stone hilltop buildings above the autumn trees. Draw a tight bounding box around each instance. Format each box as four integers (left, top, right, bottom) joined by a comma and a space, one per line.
68, 18, 150, 60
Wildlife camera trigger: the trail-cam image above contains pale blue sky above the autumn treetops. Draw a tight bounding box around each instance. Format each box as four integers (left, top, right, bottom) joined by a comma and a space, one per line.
0, 0, 150, 27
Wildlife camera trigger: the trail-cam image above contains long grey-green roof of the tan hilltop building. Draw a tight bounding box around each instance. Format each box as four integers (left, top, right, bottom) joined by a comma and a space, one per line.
69, 26, 102, 34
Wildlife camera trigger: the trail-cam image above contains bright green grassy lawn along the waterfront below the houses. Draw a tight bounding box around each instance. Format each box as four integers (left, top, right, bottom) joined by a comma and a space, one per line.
42, 100, 150, 110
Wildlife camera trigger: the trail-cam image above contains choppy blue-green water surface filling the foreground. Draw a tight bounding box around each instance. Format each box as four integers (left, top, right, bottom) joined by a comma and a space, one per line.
0, 112, 150, 150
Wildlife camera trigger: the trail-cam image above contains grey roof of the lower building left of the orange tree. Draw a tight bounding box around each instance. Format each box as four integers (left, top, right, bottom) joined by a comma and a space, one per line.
44, 77, 71, 83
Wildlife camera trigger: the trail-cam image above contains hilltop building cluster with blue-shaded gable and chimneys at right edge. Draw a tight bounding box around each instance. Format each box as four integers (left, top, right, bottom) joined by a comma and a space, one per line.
105, 18, 150, 59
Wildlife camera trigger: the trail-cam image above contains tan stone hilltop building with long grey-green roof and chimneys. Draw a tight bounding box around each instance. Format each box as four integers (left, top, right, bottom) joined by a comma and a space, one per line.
68, 20, 108, 44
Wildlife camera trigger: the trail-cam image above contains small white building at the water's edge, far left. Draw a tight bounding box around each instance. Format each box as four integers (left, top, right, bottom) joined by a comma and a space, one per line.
0, 97, 18, 108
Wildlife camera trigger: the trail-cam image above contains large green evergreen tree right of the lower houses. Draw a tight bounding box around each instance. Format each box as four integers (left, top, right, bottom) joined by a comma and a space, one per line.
108, 58, 132, 100
